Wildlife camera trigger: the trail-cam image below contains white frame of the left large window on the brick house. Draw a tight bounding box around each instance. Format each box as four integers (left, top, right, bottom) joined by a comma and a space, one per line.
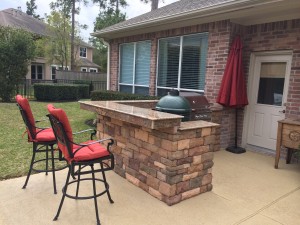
118, 40, 152, 95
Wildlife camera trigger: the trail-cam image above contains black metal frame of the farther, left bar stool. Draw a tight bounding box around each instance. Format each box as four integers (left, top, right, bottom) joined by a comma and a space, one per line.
17, 103, 66, 194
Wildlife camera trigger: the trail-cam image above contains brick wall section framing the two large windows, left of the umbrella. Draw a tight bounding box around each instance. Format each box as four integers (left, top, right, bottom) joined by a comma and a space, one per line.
110, 21, 231, 102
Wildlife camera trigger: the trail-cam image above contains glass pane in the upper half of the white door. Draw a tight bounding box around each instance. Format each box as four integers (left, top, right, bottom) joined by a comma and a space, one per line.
257, 62, 286, 106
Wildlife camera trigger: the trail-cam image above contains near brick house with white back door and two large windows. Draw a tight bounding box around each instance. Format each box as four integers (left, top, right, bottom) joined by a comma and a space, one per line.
92, 0, 300, 153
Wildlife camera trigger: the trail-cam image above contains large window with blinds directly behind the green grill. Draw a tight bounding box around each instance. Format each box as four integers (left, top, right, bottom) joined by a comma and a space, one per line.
157, 33, 208, 96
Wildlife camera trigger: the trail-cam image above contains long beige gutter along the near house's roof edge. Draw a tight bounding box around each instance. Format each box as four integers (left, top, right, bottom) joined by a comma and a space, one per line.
91, 0, 284, 37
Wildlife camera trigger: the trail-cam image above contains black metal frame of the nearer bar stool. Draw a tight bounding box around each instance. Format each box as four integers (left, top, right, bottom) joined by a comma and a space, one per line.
47, 114, 114, 225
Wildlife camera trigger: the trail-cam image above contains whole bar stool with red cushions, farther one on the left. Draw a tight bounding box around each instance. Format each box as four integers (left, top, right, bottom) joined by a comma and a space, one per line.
16, 95, 65, 194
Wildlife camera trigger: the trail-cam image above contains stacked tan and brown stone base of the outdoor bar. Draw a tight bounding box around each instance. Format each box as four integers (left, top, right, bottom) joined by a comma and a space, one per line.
97, 114, 220, 205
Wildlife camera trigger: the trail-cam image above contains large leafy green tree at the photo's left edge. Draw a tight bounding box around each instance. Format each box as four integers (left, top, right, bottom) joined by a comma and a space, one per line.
0, 26, 35, 102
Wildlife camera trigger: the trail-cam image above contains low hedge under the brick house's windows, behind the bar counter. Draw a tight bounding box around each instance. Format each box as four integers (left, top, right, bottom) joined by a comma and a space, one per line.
91, 91, 159, 101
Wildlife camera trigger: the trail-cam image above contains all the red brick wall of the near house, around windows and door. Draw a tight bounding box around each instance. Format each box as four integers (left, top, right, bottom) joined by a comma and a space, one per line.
110, 20, 300, 147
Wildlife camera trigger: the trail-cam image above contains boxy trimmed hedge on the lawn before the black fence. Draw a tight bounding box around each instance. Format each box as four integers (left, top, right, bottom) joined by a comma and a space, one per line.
34, 84, 89, 101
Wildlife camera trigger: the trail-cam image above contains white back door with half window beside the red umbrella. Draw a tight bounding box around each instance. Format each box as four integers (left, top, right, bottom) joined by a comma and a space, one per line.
247, 55, 292, 151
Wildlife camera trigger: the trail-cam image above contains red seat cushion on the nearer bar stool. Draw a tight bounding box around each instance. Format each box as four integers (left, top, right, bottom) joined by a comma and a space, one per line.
73, 140, 109, 162
